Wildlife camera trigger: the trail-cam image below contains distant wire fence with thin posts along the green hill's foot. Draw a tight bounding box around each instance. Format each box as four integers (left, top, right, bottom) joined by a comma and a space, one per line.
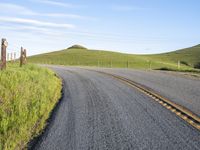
41, 57, 188, 70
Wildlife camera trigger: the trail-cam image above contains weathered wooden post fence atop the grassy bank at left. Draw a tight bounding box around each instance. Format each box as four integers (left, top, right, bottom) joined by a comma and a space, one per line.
0, 38, 27, 70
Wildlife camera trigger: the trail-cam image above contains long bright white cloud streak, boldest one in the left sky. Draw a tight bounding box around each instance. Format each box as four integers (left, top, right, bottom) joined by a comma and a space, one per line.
0, 17, 75, 29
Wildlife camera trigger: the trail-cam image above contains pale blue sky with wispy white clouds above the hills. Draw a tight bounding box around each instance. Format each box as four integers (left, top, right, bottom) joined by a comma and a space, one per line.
0, 0, 200, 55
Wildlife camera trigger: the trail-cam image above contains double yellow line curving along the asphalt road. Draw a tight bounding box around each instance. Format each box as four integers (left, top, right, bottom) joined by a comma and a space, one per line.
90, 69, 200, 131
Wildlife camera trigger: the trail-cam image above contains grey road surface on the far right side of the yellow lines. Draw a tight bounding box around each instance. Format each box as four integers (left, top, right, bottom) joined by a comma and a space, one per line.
95, 69, 200, 117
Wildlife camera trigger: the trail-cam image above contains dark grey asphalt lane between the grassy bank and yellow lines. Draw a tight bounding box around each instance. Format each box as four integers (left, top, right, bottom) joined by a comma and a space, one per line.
33, 67, 200, 150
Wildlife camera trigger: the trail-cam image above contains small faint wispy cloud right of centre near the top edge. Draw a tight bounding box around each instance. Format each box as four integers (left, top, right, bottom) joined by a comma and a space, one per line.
111, 5, 144, 11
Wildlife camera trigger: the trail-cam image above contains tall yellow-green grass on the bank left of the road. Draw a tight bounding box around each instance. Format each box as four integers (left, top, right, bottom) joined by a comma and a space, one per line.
0, 64, 61, 150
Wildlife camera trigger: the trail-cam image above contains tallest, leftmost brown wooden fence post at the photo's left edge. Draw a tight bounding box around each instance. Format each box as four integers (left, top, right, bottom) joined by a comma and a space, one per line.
0, 39, 8, 70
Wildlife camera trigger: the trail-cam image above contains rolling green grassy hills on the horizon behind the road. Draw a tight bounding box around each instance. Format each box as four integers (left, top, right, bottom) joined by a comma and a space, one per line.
29, 45, 200, 69
